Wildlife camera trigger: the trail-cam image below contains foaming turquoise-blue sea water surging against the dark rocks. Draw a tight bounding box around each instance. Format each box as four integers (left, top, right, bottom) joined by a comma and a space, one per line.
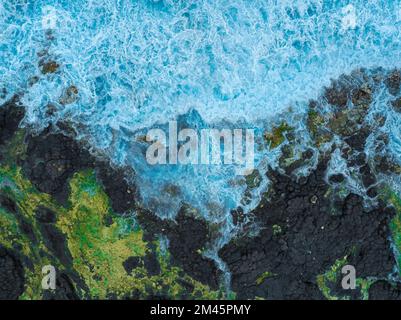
0, 0, 401, 235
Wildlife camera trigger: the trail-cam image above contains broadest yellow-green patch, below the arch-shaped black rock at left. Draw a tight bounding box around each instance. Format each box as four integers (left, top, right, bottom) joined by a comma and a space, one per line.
57, 171, 147, 298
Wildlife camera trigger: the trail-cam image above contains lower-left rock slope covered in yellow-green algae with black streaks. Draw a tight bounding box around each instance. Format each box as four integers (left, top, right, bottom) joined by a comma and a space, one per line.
0, 99, 220, 300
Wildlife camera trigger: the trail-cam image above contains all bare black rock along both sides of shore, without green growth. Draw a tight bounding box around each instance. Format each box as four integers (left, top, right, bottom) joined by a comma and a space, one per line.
0, 71, 401, 299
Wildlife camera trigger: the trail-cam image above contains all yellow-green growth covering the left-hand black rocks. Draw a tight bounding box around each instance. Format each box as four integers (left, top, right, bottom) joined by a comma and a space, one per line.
0, 166, 223, 299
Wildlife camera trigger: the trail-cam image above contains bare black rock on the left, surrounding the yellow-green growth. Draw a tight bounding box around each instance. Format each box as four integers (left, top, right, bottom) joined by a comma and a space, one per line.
0, 98, 219, 299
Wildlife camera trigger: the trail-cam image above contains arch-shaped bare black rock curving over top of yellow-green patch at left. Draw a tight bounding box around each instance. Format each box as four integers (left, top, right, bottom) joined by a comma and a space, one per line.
22, 128, 137, 213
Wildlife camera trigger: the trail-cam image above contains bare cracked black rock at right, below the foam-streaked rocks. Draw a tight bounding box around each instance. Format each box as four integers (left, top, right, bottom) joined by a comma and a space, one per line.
220, 160, 395, 299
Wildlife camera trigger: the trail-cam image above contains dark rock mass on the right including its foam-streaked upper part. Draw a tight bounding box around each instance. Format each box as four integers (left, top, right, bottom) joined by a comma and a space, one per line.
219, 69, 400, 299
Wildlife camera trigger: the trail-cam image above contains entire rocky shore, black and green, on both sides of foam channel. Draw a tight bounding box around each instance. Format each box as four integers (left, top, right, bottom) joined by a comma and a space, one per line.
0, 69, 401, 299
